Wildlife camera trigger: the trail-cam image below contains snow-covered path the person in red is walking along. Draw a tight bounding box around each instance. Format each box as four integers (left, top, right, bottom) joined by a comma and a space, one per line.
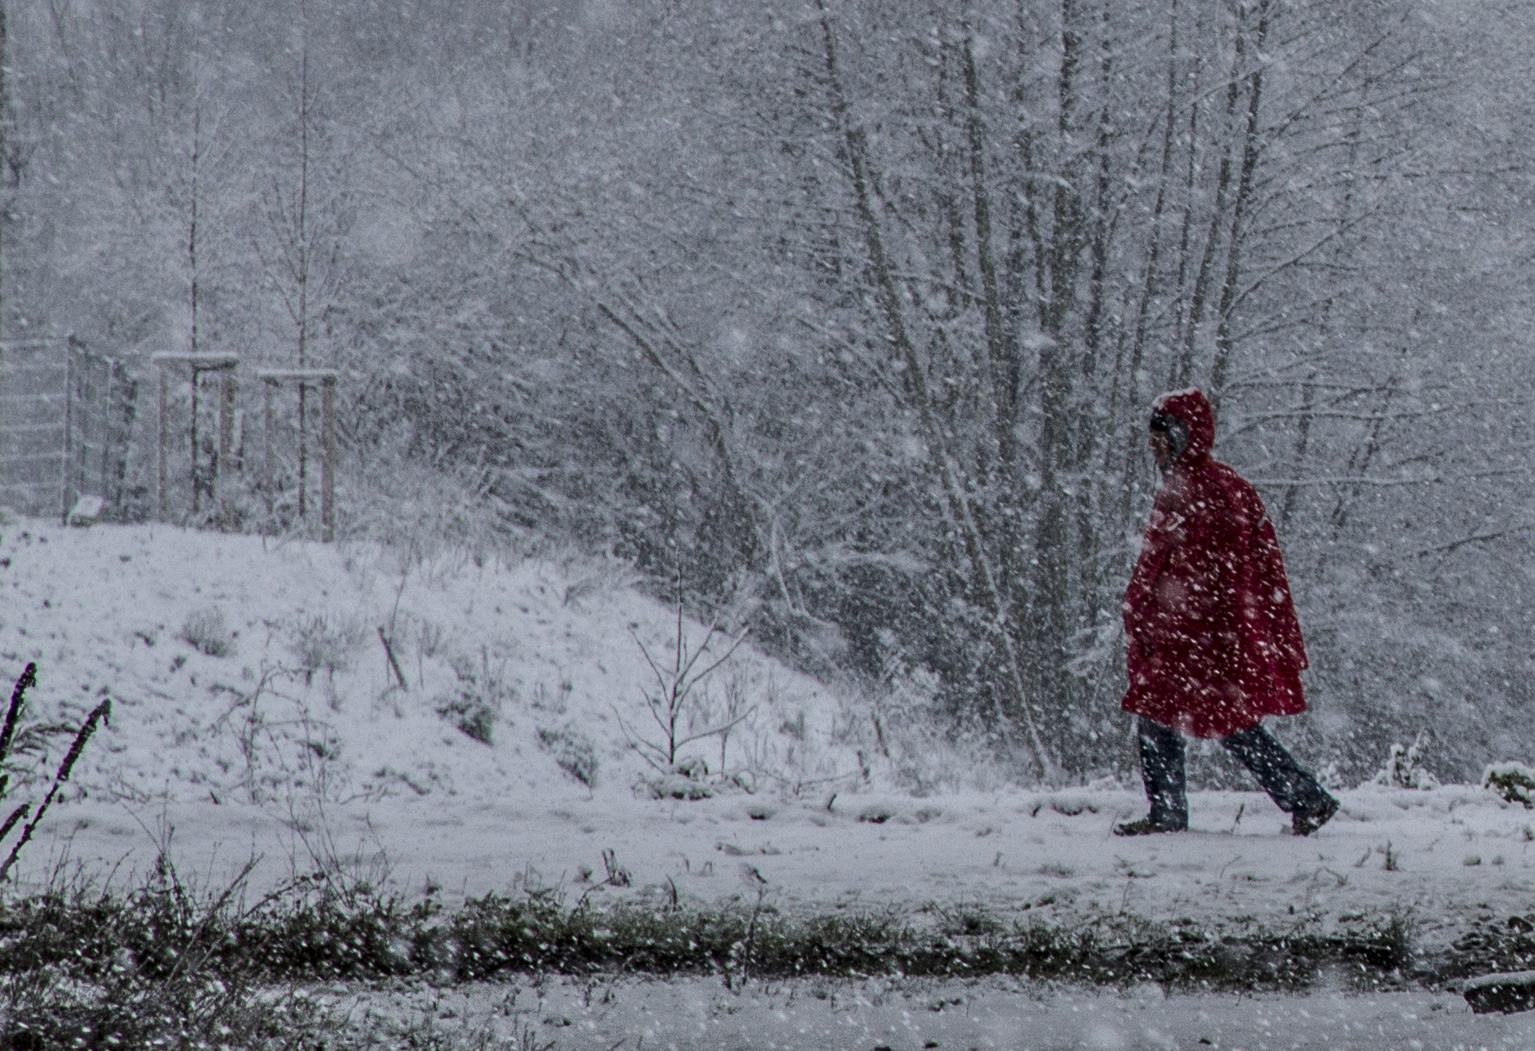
28, 786, 1535, 945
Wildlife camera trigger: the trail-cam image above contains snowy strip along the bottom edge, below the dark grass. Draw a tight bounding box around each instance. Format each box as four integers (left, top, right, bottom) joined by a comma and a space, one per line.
330, 979, 1535, 1051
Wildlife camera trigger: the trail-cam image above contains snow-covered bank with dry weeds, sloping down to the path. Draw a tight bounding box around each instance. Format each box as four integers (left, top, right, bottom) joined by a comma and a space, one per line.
0, 520, 858, 807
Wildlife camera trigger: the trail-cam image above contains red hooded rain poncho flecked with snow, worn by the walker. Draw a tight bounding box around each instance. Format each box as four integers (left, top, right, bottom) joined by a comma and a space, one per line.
1122, 390, 1306, 736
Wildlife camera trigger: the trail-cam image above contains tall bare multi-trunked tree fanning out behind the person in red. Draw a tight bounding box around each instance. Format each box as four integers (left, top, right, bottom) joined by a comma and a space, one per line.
730, 0, 1436, 776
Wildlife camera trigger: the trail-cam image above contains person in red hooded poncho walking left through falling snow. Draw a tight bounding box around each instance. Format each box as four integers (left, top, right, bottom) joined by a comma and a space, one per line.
1114, 390, 1339, 836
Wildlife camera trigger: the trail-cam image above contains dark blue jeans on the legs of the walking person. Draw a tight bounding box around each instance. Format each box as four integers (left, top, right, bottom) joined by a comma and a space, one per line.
1136, 715, 1332, 829
